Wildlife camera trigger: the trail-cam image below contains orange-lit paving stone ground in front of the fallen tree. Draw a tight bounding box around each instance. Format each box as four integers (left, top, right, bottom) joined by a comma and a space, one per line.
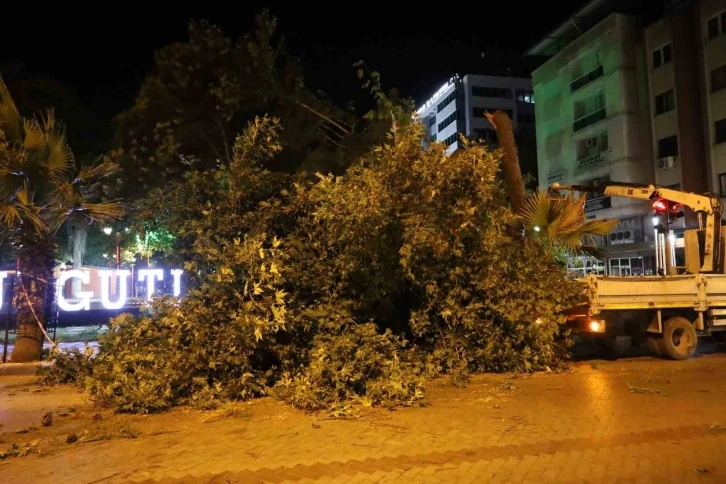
0, 354, 726, 484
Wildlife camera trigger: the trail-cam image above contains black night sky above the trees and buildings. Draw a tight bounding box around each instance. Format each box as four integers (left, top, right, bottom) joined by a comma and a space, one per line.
0, 0, 583, 118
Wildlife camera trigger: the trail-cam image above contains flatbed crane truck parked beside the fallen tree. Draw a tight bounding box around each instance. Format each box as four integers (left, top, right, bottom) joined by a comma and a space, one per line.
549, 182, 726, 360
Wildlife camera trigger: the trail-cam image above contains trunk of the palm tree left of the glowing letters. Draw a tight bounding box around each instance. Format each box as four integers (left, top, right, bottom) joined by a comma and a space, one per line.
10, 238, 54, 363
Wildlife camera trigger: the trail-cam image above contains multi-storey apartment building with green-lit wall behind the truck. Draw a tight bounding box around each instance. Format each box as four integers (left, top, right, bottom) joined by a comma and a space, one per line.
528, 0, 726, 275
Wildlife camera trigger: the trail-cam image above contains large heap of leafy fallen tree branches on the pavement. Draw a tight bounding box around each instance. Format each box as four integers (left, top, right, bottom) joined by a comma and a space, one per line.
51, 102, 580, 415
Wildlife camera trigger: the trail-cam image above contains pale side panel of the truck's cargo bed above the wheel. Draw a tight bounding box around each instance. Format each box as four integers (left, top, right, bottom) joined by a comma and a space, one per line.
584, 274, 726, 315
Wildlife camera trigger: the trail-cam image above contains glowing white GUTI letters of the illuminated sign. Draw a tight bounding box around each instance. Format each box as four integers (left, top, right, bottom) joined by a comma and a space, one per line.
0, 269, 184, 311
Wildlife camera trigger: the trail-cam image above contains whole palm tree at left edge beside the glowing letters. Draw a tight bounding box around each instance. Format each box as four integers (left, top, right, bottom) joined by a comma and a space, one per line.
0, 79, 123, 362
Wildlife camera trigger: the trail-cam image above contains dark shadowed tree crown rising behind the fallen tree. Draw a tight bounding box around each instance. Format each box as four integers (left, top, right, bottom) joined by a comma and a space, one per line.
113, 11, 352, 199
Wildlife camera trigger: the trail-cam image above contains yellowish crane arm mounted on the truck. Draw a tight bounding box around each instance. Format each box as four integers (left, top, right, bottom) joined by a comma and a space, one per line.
550, 182, 723, 272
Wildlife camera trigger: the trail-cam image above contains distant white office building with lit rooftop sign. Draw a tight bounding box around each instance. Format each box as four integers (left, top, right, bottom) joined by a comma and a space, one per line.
416, 74, 534, 153
